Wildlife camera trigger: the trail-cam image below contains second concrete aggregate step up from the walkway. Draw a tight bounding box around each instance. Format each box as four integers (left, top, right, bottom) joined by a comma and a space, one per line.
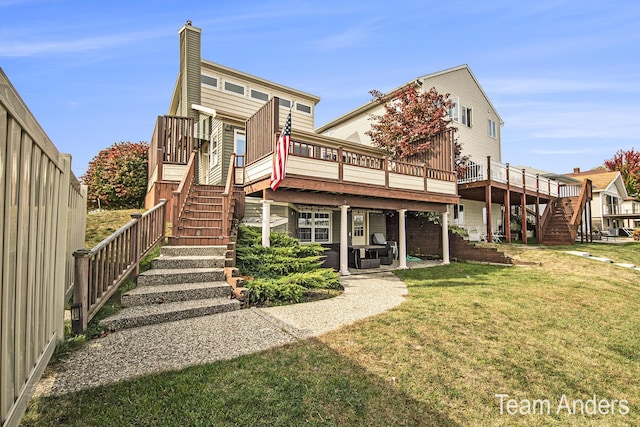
121, 282, 232, 307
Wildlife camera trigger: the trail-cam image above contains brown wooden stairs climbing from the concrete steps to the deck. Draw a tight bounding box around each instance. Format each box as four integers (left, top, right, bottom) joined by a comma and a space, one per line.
169, 184, 233, 246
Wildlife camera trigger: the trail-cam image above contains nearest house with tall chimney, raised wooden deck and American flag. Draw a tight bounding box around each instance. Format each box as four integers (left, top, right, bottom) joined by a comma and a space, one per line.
146, 22, 459, 274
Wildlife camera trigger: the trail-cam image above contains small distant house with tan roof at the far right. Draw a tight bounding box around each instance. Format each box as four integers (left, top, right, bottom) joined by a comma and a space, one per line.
567, 168, 640, 236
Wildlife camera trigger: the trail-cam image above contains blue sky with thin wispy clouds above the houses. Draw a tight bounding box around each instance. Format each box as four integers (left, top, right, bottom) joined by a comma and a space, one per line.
0, 0, 640, 176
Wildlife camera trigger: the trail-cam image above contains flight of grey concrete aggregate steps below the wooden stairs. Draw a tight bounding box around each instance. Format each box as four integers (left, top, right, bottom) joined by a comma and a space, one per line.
102, 246, 240, 331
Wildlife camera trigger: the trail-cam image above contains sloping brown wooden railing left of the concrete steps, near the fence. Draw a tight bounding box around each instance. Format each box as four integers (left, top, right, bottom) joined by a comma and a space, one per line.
71, 199, 166, 334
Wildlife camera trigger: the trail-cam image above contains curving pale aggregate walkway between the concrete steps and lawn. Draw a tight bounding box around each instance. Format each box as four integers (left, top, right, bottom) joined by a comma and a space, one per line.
35, 261, 436, 395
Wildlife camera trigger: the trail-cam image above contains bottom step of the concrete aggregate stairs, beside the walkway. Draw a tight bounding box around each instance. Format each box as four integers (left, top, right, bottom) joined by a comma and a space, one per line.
101, 298, 240, 331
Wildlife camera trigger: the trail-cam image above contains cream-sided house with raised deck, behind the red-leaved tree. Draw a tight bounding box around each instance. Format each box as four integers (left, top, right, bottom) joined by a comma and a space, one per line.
317, 65, 582, 244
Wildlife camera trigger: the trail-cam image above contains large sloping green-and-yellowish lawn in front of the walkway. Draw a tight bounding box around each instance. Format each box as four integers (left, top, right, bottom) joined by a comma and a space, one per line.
23, 245, 640, 426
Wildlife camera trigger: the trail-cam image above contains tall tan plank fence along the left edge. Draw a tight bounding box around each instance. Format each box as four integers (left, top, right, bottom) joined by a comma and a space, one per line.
0, 69, 86, 426
